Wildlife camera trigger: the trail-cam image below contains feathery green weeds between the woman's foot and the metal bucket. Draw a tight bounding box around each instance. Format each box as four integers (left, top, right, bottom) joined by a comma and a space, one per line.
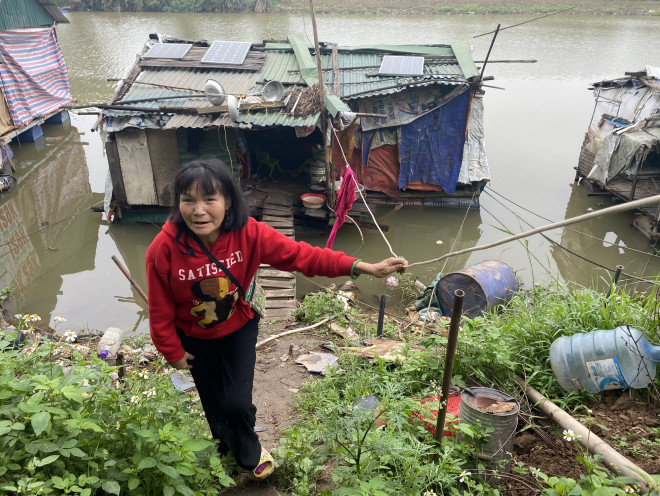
275, 351, 495, 495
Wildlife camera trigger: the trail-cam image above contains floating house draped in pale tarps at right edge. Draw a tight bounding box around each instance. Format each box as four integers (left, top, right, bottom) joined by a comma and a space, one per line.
575, 66, 660, 241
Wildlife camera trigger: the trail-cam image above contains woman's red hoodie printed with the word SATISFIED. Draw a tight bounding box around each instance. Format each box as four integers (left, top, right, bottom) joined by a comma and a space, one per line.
146, 218, 356, 362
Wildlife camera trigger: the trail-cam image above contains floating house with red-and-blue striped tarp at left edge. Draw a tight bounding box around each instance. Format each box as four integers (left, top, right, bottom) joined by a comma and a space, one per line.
0, 0, 71, 172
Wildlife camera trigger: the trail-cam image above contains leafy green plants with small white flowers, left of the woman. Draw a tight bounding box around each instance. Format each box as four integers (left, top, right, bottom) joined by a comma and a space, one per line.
0, 336, 233, 496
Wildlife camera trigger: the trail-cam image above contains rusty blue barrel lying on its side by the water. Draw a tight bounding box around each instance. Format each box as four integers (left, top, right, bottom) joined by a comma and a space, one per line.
435, 260, 519, 317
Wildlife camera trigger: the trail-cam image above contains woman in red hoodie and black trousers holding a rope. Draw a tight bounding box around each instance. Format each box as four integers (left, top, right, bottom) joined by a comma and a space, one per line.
146, 158, 408, 478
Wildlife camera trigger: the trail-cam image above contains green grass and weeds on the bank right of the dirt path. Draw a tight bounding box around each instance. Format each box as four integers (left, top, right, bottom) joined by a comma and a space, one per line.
268, 284, 659, 496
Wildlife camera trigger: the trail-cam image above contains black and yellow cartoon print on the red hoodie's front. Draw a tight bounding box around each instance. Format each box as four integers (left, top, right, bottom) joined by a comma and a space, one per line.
190, 277, 239, 329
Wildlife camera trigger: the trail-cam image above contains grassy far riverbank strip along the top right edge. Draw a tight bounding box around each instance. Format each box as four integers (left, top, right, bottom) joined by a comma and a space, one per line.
276, 0, 660, 15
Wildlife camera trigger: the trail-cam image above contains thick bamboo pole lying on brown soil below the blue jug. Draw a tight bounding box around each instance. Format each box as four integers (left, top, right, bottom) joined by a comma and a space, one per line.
513, 376, 653, 492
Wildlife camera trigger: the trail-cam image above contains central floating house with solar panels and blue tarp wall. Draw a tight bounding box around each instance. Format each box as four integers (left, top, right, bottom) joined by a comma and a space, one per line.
102, 35, 490, 220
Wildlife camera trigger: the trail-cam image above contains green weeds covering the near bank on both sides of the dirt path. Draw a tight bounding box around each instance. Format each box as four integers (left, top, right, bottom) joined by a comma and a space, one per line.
0, 281, 660, 496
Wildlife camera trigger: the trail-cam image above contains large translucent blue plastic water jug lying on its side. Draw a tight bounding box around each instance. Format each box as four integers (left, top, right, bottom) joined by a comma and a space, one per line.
550, 326, 660, 393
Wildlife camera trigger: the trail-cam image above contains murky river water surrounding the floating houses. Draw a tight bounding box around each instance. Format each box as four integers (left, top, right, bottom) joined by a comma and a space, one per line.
0, 12, 660, 332
